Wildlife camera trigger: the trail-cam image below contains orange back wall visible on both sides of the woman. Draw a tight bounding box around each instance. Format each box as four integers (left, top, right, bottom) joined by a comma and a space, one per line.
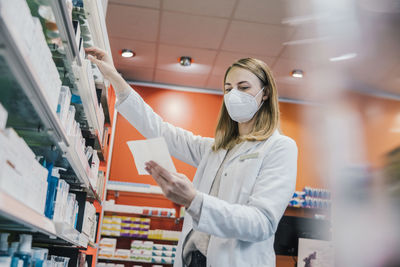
110, 87, 322, 190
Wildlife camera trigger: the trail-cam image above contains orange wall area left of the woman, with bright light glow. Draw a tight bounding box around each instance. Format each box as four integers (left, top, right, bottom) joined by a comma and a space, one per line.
110, 87, 221, 185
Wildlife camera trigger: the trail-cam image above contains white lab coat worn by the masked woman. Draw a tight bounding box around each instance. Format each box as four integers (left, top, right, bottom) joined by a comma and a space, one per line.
117, 91, 297, 267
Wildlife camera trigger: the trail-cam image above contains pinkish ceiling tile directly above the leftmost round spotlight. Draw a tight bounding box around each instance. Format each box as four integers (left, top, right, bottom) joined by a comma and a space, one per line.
107, 4, 160, 41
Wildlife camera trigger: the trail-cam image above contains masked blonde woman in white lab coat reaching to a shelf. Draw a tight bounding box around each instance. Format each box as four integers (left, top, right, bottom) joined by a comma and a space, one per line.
86, 48, 297, 267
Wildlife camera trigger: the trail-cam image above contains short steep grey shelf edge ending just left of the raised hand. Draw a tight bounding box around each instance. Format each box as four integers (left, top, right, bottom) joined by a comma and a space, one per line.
49, 0, 81, 66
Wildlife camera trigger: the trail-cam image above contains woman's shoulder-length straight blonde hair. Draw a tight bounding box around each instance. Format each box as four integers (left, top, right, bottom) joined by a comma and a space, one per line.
212, 58, 279, 151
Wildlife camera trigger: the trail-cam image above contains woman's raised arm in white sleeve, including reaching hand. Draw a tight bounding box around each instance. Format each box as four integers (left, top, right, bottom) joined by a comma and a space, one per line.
86, 48, 213, 167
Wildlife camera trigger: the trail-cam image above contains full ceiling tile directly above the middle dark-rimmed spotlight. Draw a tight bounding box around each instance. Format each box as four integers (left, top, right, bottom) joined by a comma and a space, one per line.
160, 12, 228, 49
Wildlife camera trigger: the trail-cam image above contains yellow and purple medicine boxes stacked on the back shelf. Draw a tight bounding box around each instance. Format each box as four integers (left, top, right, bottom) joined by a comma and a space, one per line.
101, 216, 150, 238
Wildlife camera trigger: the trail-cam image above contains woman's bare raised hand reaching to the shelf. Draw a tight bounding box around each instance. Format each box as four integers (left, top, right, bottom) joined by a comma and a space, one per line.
85, 47, 118, 79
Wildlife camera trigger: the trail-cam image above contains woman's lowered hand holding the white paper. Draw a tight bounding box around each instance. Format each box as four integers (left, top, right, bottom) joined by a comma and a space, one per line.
146, 161, 197, 208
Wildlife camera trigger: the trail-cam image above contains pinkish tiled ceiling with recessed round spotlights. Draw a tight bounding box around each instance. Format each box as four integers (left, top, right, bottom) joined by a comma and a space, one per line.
107, 0, 400, 99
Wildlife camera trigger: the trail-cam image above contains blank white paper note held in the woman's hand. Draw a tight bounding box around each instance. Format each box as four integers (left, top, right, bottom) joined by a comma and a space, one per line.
127, 137, 176, 175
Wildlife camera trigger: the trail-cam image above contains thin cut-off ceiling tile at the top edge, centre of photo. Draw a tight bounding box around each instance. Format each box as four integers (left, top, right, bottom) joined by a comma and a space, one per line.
163, 0, 235, 18
